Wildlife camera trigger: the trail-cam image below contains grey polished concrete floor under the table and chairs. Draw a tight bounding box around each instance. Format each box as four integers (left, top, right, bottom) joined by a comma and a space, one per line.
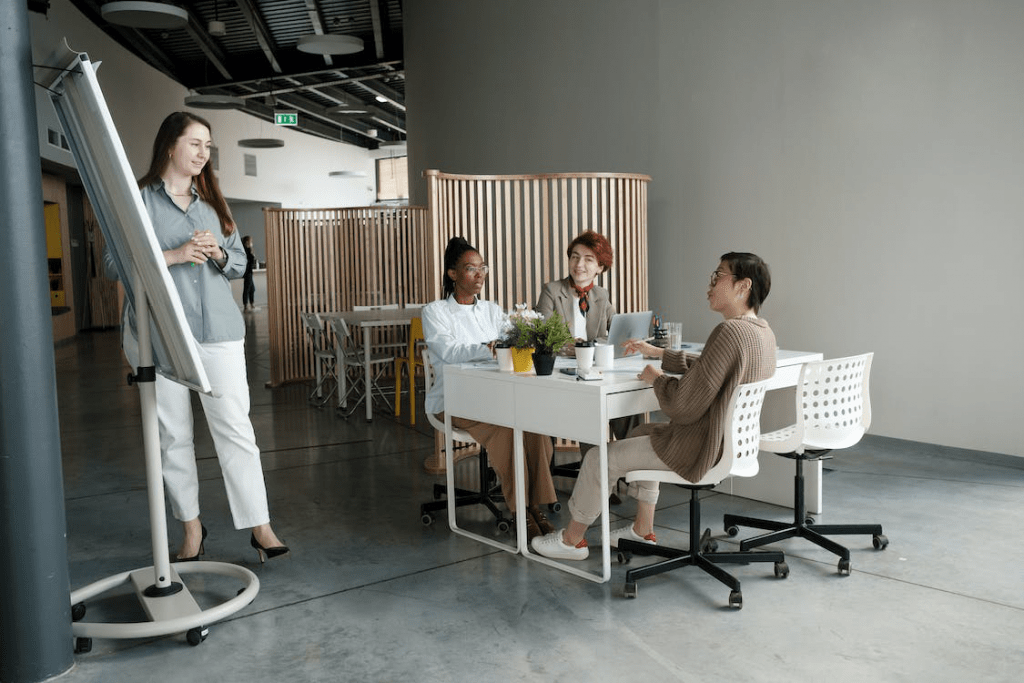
56, 309, 1024, 683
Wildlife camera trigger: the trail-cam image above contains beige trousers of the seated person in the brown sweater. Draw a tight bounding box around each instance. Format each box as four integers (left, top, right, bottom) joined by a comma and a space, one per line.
569, 425, 669, 526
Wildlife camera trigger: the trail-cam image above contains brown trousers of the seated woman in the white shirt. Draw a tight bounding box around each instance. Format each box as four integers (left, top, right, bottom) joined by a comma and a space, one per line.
437, 413, 558, 512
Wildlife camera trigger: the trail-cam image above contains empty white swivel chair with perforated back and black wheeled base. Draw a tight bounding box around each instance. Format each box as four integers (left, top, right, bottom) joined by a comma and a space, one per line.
724, 353, 889, 574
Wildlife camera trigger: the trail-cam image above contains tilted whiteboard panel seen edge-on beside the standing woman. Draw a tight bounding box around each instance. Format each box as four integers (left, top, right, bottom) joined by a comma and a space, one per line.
49, 52, 211, 393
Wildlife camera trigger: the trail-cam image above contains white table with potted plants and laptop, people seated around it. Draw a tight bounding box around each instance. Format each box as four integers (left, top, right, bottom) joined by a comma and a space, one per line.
443, 344, 821, 583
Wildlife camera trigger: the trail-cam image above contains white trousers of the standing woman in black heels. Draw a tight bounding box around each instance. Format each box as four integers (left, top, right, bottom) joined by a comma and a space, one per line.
157, 340, 270, 528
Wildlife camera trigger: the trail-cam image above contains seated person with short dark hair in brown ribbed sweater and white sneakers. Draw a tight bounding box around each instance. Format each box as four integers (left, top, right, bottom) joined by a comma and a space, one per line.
531, 252, 776, 560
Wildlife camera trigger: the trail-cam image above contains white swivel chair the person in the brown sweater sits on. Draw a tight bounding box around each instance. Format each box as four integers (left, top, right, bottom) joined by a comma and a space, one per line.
618, 380, 790, 608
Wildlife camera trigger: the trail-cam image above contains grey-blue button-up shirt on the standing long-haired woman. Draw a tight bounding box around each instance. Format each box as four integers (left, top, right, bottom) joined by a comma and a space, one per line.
105, 181, 246, 343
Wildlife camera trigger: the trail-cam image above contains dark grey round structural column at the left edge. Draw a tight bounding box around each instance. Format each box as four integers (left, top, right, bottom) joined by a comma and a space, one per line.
0, 0, 74, 683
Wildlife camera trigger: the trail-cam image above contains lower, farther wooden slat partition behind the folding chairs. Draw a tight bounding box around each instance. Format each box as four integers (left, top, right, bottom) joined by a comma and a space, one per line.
264, 207, 433, 386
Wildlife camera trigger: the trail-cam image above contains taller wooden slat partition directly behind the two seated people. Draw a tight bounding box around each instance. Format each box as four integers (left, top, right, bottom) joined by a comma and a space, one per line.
424, 170, 650, 312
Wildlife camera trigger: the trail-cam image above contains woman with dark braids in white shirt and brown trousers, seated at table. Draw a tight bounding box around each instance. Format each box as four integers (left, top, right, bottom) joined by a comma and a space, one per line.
422, 238, 558, 540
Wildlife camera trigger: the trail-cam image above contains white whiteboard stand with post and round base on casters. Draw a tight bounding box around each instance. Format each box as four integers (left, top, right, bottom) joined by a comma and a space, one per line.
71, 274, 259, 652
